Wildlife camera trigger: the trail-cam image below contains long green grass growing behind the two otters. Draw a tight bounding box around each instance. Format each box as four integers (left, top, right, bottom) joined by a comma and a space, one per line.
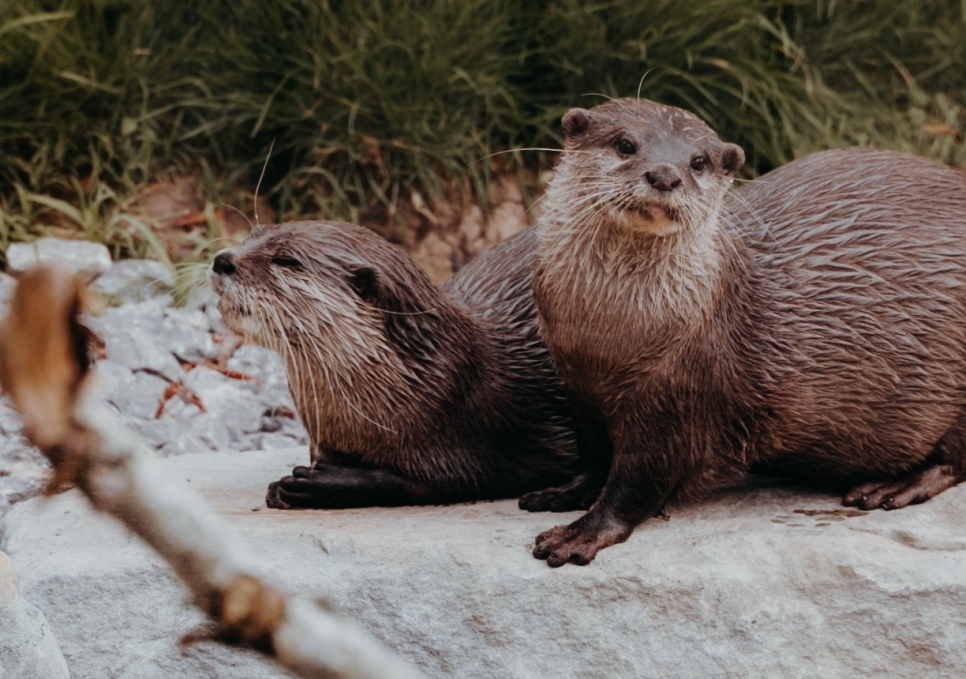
0, 0, 966, 266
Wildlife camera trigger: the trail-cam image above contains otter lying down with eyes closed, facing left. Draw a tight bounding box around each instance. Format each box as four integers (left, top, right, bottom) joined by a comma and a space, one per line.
210, 221, 578, 509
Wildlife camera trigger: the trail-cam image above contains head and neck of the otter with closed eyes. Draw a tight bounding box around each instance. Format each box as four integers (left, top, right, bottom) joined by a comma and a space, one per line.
210, 222, 449, 451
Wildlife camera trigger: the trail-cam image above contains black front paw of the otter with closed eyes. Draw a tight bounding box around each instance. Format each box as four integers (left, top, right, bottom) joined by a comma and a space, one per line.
265, 462, 427, 509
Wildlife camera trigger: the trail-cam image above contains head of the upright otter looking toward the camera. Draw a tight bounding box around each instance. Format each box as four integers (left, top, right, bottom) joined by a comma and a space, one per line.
560, 99, 745, 235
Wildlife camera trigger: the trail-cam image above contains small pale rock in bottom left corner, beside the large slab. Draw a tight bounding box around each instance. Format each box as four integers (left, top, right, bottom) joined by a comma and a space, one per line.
0, 552, 69, 679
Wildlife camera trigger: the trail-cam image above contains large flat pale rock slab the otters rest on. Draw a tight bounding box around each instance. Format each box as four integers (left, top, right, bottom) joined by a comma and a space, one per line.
0, 450, 966, 679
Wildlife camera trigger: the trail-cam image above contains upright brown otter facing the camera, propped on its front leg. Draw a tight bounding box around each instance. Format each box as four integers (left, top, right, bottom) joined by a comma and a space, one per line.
532, 99, 966, 567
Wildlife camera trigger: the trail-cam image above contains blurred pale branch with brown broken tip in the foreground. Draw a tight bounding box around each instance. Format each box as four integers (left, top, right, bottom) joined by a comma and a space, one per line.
0, 267, 421, 679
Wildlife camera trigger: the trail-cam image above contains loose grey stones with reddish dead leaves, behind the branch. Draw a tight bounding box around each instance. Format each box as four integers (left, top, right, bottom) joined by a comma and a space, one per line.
0, 240, 308, 518
